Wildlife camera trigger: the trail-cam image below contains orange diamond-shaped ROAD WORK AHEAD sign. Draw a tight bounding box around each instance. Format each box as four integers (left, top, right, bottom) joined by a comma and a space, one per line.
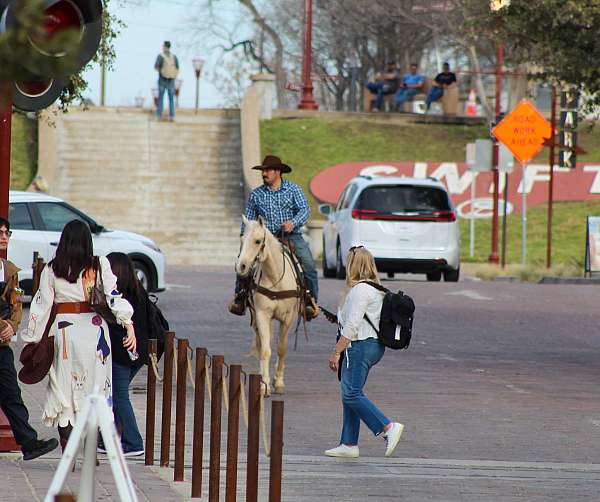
492, 99, 552, 164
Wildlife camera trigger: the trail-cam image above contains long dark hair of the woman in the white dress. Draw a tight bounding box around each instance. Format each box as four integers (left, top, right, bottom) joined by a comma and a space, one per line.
50, 220, 94, 283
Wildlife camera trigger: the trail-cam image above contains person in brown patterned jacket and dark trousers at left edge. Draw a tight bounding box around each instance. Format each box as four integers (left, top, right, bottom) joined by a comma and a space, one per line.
0, 218, 58, 460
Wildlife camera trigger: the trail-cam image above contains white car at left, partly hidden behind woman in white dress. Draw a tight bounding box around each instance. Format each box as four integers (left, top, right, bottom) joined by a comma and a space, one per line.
8, 191, 165, 292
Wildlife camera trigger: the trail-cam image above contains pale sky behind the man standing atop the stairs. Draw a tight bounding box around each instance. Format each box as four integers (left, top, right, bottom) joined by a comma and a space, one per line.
84, 0, 241, 108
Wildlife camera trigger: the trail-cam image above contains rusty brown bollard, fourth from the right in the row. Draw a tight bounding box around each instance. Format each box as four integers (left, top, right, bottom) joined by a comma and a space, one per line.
208, 356, 225, 502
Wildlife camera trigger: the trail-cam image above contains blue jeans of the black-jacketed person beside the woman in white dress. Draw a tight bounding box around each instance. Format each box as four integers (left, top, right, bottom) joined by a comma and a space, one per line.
112, 359, 144, 453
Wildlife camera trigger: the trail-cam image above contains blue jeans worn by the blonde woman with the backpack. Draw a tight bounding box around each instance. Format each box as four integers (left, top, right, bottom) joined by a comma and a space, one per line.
340, 338, 390, 446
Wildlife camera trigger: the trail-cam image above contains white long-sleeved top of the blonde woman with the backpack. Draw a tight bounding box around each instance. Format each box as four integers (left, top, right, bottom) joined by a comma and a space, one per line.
338, 282, 385, 341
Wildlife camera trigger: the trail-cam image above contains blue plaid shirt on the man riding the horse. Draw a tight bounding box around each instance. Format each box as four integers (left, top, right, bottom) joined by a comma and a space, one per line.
241, 180, 310, 234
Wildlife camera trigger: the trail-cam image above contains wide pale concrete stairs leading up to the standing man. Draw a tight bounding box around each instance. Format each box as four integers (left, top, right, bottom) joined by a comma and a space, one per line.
51, 108, 244, 265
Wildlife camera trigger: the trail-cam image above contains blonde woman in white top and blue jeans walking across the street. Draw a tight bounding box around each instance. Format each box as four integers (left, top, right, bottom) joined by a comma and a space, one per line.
325, 246, 404, 458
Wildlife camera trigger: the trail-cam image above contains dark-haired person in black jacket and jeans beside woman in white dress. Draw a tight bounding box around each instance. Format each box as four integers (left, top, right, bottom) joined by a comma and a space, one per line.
99, 253, 149, 457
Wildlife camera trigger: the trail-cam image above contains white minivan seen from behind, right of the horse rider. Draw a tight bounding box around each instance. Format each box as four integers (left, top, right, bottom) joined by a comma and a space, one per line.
319, 176, 460, 282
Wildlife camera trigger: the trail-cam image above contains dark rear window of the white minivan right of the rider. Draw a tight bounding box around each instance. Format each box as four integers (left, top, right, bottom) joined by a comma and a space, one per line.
356, 185, 450, 213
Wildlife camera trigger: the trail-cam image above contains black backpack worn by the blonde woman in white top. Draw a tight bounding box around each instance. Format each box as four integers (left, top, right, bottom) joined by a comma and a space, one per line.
363, 281, 415, 350
